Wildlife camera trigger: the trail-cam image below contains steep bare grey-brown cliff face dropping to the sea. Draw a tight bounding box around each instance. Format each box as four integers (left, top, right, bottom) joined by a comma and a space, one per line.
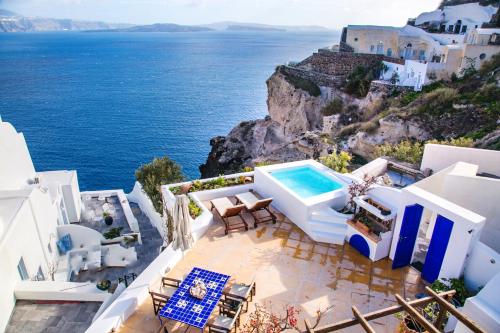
200, 72, 334, 178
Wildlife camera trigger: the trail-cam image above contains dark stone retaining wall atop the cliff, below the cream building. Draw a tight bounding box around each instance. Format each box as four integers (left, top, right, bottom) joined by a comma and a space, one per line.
297, 49, 404, 78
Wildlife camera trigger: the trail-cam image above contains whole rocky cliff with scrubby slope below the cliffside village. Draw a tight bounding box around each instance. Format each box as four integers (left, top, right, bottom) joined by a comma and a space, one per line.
200, 53, 500, 177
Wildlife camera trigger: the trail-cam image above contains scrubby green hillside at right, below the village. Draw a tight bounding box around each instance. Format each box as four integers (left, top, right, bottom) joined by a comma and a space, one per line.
336, 54, 500, 154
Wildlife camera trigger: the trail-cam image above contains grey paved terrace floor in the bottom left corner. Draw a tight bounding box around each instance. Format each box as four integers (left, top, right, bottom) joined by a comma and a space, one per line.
5, 301, 101, 333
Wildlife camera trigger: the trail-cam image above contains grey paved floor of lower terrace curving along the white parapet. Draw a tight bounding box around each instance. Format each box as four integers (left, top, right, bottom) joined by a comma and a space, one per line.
72, 203, 163, 282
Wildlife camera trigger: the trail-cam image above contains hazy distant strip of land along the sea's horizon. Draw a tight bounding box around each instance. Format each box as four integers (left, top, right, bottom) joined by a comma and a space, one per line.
0, 9, 336, 32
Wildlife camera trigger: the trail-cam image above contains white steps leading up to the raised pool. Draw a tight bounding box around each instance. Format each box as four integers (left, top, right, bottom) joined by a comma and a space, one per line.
309, 207, 352, 244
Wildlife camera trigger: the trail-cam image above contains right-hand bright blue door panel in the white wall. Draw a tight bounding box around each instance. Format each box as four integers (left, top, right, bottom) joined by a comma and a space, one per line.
422, 215, 453, 283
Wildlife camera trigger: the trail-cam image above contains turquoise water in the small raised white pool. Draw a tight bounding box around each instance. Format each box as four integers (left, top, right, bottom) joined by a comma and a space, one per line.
271, 166, 342, 199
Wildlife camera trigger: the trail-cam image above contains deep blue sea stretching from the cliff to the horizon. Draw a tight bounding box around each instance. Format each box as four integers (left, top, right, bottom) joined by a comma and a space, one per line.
0, 32, 339, 191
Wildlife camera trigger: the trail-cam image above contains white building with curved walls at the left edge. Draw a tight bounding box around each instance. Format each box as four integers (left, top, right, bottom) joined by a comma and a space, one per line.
0, 118, 136, 331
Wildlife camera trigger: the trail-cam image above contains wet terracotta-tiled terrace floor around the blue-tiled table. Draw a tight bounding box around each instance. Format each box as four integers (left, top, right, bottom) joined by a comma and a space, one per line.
119, 197, 424, 333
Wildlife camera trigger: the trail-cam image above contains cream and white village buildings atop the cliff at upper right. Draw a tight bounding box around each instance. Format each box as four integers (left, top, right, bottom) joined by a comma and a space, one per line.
338, 2, 500, 90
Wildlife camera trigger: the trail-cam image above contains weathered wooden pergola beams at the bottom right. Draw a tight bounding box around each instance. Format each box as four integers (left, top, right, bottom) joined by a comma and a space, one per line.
305, 287, 486, 333
